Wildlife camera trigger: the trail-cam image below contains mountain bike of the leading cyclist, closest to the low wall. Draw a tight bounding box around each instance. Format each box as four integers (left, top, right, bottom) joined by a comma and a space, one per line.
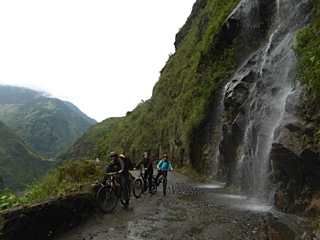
96, 172, 130, 213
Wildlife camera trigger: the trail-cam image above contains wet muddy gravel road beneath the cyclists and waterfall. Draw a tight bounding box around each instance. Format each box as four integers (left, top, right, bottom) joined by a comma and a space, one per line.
58, 172, 312, 240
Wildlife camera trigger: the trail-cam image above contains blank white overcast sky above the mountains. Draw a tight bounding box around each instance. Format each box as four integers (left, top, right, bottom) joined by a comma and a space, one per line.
0, 0, 196, 122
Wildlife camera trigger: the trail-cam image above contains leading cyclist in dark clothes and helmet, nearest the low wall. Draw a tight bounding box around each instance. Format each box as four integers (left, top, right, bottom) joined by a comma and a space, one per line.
103, 151, 130, 208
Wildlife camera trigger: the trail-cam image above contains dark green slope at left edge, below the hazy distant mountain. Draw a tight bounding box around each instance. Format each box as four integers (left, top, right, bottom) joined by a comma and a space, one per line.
0, 122, 52, 192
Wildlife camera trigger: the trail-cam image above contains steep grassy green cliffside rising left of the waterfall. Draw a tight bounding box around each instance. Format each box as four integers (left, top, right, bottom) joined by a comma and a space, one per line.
90, 0, 238, 171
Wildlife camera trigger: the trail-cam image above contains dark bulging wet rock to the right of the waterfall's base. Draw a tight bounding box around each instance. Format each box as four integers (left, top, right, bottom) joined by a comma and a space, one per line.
270, 89, 320, 216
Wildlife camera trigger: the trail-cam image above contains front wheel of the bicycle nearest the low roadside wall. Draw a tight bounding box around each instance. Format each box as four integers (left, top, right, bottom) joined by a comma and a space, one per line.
96, 186, 118, 213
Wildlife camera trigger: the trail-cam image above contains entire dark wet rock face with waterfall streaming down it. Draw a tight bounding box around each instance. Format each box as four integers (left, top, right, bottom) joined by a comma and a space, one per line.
219, 0, 320, 213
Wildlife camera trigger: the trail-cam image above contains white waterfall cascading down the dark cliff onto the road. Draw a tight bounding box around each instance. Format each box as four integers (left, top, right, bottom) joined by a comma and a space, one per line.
220, 0, 312, 200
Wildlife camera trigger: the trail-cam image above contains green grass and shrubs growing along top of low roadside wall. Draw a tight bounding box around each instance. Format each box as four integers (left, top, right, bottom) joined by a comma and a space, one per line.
0, 159, 107, 211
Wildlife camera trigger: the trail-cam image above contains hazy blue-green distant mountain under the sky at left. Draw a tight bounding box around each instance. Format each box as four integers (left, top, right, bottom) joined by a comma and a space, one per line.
0, 86, 96, 158
